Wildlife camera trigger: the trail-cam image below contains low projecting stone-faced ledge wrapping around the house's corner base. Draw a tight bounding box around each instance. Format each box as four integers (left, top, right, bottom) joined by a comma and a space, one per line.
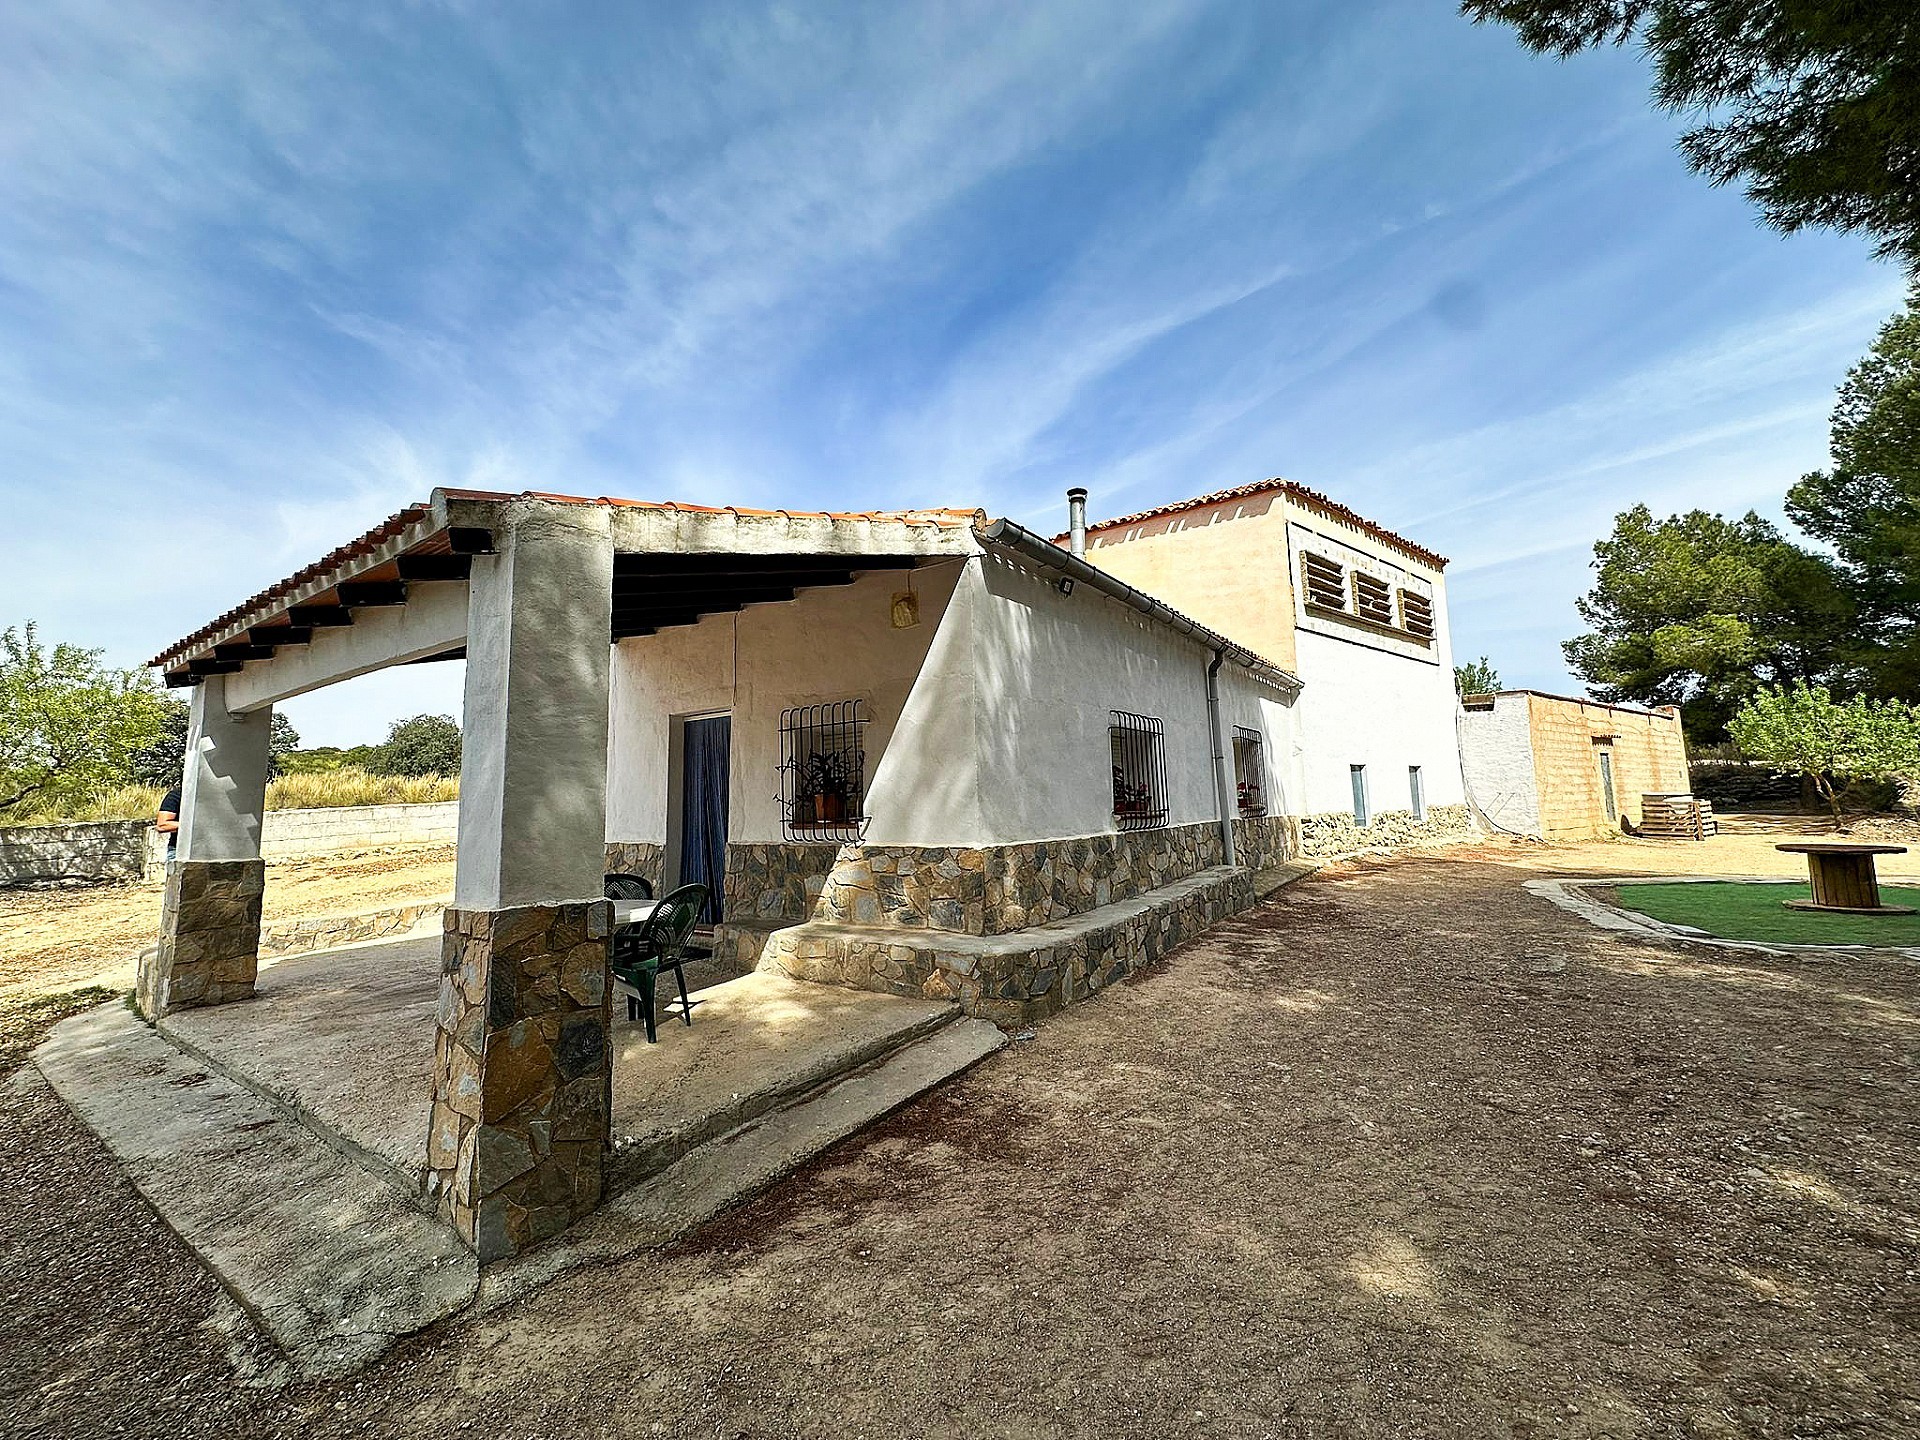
756, 866, 1258, 1025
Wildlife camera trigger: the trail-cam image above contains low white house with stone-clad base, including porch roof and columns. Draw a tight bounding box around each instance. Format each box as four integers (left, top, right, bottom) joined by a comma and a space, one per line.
138, 490, 1308, 1258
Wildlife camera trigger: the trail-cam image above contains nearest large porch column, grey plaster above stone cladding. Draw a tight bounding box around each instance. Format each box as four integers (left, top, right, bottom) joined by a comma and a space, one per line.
428, 501, 612, 1261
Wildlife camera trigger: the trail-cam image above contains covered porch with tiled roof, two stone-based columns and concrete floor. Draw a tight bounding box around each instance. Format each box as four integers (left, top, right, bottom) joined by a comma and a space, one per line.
138, 492, 985, 1261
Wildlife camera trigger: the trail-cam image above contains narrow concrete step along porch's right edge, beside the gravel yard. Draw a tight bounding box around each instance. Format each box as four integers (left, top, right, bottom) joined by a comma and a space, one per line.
476, 1020, 1006, 1309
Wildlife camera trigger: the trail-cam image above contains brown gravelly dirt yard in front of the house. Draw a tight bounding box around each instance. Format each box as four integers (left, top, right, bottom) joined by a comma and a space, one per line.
0, 835, 1920, 1438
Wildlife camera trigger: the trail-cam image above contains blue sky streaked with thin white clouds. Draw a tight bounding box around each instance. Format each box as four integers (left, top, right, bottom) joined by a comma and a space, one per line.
0, 0, 1901, 743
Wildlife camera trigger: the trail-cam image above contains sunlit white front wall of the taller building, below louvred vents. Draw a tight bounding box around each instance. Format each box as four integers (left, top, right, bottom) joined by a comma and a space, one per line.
1286, 511, 1465, 814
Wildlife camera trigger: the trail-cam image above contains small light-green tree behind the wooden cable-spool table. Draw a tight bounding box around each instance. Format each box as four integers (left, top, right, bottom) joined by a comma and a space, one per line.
1726, 684, 1920, 829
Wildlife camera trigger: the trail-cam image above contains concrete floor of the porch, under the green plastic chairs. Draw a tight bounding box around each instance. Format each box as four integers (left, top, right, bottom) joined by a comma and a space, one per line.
159, 935, 958, 1194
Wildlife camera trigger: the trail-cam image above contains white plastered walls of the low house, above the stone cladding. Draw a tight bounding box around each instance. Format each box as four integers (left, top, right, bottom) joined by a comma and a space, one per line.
607, 553, 1302, 847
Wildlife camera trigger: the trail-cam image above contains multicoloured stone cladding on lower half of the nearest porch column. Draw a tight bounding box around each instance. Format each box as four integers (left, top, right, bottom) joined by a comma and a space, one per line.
426, 900, 612, 1263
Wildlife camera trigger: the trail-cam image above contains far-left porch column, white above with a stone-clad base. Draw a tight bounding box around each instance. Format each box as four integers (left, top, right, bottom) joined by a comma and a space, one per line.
138, 676, 273, 1020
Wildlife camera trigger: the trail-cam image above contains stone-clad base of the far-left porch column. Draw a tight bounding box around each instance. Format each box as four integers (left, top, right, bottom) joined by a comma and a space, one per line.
134, 860, 267, 1020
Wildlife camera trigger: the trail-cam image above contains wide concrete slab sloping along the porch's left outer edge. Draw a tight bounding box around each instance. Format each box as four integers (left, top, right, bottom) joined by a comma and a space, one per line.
35, 1000, 478, 1377
